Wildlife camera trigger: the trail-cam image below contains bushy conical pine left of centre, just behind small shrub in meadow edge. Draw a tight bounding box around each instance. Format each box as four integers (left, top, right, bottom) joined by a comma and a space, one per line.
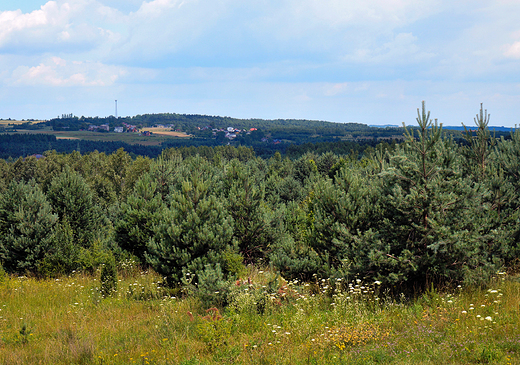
145, 169, 237, 286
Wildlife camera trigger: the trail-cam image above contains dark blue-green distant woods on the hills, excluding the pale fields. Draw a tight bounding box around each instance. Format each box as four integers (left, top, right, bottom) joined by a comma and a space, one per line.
10, 113, 509, 159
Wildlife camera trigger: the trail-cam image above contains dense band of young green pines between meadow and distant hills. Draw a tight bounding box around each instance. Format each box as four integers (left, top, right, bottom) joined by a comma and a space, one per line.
0, 104, 520, 303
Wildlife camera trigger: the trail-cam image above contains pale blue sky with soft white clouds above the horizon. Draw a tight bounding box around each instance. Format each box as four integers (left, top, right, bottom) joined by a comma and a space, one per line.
0, 0, 520, 127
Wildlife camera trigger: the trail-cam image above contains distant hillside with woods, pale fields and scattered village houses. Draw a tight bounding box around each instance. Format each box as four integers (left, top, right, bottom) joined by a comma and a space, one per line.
0, 110, 414, 159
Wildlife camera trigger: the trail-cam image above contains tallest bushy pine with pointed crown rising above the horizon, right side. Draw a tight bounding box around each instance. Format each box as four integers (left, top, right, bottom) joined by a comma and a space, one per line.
373, 102, 497, 286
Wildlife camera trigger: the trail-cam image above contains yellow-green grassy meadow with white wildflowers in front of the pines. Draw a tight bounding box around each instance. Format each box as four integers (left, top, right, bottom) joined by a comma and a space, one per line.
0, 268, 520, 365
